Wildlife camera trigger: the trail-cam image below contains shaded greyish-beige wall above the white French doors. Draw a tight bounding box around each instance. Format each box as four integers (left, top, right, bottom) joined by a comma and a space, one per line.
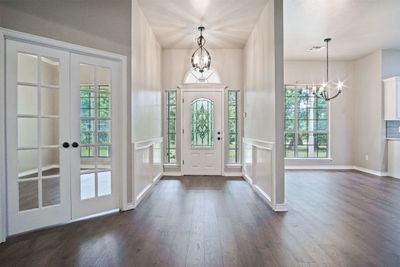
0, 0, 131, 57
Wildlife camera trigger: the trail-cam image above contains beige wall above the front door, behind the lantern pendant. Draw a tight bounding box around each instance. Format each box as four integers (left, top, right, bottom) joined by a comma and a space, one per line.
162, 49, 243, 90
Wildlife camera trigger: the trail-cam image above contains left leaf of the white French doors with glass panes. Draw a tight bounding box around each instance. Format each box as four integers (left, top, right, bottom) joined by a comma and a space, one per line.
6, 40, 71, 235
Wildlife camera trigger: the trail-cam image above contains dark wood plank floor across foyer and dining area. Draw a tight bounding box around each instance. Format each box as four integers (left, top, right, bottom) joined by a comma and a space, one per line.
0, 171, 400, 267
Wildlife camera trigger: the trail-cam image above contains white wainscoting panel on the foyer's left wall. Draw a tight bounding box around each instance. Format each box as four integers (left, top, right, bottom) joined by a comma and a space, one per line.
130, 137, 163, 208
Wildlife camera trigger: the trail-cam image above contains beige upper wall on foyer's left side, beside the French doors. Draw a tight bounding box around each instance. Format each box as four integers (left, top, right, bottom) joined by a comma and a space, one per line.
128, 0, 162, 202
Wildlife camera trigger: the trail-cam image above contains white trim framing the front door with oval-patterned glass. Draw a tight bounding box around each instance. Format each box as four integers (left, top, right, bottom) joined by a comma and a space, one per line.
177, 83, 228, 175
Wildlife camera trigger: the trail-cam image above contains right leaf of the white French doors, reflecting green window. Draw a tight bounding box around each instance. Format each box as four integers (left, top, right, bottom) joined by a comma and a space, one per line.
71, 54, 121, 219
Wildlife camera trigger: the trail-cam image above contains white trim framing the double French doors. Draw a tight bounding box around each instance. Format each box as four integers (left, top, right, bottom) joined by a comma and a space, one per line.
0, 27, 128, 242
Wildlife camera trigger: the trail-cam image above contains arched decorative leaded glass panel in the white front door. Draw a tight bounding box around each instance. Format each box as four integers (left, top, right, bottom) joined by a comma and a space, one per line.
192, 98, 214, 148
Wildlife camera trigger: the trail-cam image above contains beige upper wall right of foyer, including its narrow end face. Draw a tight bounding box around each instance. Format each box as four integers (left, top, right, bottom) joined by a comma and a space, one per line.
243, 0, 284, 203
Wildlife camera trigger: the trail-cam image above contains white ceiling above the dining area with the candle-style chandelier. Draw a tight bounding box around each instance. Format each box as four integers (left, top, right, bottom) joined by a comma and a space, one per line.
284, 0, 400, 59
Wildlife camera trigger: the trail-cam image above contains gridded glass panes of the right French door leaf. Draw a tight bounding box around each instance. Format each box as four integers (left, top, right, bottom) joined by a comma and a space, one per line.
79, 64, 112, 200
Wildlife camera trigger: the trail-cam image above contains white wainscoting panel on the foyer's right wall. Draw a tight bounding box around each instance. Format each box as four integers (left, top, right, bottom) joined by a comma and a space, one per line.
243, 138, 281, 211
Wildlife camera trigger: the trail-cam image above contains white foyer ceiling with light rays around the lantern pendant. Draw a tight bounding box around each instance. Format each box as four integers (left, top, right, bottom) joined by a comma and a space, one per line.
138, 0, 268, 48
